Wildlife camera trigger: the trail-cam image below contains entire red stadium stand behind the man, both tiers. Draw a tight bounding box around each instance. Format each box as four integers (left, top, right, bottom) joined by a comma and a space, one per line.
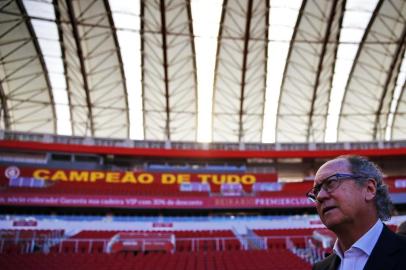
0, 137, 406, 270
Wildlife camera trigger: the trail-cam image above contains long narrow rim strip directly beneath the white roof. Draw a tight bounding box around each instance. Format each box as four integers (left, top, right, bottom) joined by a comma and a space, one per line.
0, 130, 406, 151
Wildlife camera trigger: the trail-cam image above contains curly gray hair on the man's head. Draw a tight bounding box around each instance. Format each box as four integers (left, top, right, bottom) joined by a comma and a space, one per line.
339, 155, 393, 221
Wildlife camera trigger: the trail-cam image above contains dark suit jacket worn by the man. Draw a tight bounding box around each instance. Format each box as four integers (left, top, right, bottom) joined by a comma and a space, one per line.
313, 226, 406, 270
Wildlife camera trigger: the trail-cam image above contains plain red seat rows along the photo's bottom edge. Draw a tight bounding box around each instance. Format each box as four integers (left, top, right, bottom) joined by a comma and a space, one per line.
0, 250, 311, 270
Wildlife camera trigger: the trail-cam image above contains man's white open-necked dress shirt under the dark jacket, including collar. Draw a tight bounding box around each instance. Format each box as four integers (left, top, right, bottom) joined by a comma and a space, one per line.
333, 219, 383, 270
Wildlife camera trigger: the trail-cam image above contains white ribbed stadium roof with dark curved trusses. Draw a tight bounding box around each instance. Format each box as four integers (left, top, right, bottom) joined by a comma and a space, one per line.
0, 0, 406, 143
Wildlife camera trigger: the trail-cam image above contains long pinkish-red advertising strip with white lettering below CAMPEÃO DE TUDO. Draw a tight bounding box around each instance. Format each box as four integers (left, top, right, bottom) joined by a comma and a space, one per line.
0, 193, 314, 209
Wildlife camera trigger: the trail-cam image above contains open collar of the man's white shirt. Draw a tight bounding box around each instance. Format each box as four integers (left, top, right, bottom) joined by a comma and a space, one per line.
333, 219, 383, 260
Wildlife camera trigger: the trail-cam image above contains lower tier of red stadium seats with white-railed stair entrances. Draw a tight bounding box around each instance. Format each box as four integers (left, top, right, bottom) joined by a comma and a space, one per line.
0, 220, 404, 270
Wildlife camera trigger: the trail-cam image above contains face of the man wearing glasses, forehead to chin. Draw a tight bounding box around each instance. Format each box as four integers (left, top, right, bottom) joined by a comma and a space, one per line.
314, 159, 366, 230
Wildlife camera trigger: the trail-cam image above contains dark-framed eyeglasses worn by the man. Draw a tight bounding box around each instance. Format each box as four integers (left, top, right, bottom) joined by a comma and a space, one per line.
306, 173, 365, 202
